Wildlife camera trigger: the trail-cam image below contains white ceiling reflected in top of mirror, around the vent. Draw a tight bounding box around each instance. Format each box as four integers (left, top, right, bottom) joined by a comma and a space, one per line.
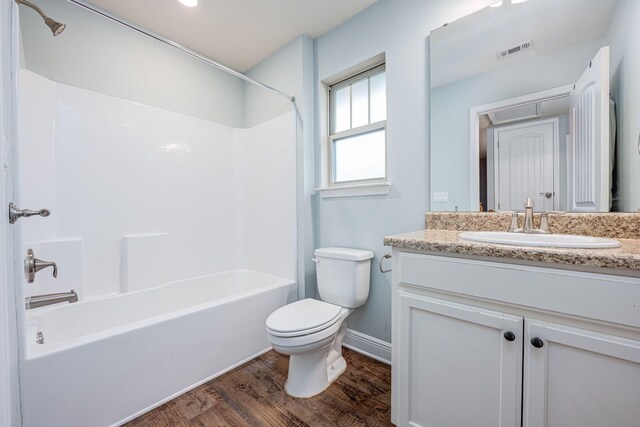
430, 0, 618, 87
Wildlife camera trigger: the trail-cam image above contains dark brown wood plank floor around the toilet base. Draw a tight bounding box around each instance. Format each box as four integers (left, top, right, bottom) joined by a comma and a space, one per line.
125, 349, 392, 427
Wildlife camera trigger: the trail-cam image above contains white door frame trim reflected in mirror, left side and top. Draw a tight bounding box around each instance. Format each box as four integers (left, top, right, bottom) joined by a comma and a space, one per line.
469, 84, 573, 212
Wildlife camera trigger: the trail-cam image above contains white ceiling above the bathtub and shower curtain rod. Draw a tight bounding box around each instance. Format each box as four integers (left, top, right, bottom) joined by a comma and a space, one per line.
84, 0, 376, 71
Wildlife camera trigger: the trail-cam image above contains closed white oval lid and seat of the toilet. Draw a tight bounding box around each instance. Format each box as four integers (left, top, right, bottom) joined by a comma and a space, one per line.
267, 298, 342, 337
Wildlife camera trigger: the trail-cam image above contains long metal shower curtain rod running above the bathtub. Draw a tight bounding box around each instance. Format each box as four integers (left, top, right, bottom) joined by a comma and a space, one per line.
68, 0, 296, 102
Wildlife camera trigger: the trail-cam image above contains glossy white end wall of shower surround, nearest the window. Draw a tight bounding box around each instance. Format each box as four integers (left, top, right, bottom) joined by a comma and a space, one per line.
232, 118, 297, 280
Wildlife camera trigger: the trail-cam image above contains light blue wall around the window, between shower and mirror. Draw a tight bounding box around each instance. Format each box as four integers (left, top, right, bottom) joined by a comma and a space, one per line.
316, 0, 491, 342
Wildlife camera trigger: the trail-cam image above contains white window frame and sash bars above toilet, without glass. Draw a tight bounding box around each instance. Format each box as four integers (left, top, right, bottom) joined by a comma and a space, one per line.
325, 62, 390, 188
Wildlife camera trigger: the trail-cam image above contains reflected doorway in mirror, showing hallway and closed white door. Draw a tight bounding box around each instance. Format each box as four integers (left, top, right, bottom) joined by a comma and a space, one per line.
471, 93, 572, 211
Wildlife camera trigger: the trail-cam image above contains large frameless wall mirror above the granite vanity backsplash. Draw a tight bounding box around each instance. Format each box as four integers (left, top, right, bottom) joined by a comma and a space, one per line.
430, 0, 640, 212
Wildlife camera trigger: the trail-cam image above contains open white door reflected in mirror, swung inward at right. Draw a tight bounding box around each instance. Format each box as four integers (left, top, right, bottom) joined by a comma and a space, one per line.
567, 46, 611, 212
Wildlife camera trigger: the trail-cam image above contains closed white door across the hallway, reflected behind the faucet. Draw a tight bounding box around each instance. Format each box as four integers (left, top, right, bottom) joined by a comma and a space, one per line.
494, 119, 558, 211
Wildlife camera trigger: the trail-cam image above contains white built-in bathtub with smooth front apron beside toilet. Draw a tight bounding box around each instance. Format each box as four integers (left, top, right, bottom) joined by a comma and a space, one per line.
20, 270, 296, 427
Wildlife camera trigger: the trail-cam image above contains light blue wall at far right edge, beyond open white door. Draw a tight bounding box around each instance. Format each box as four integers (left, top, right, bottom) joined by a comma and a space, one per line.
606, 0, 640, 212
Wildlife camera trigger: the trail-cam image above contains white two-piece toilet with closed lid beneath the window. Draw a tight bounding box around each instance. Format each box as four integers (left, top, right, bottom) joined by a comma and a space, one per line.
267, 248, 373, 397
